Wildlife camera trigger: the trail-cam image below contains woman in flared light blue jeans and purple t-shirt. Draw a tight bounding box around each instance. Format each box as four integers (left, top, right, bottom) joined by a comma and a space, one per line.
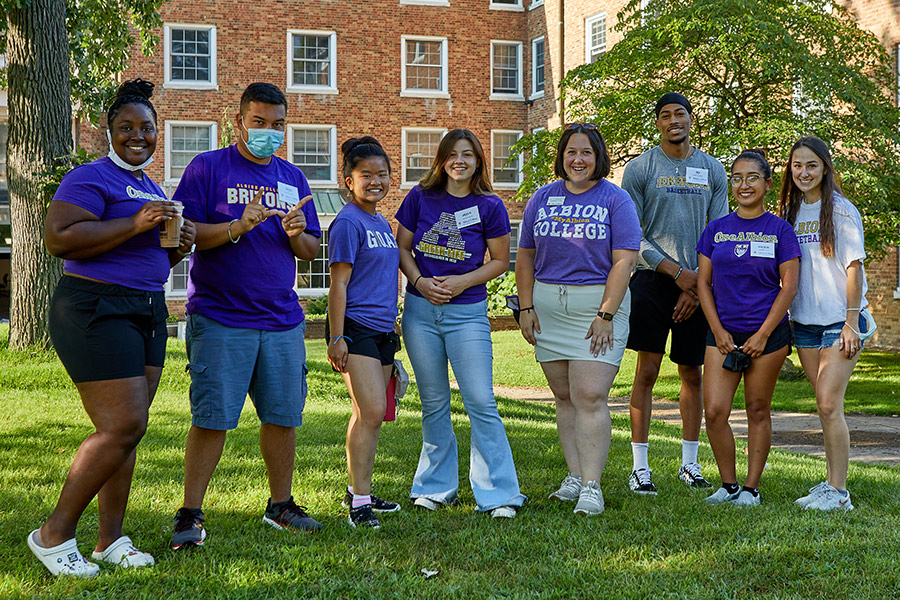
397, 129, 525, 518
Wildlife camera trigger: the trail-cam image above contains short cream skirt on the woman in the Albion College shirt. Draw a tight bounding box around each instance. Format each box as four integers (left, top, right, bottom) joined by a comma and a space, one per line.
533, 281, 631, 367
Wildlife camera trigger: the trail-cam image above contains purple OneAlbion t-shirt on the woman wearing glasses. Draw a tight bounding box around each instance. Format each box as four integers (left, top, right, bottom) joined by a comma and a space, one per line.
697, 211, 800, 333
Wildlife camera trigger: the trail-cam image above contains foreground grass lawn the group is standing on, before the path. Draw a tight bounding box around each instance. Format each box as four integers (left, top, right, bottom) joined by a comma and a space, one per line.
0, 329, 900, 600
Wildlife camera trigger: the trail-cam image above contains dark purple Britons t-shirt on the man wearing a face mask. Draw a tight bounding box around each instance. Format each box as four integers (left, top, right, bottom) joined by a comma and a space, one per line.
173, 146, 322, 331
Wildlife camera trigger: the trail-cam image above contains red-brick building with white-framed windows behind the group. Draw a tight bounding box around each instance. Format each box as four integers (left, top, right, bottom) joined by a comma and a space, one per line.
0, 0, 900, 348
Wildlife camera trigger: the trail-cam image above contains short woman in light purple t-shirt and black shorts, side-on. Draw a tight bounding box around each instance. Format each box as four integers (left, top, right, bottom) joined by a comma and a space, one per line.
328, 136, 400, 529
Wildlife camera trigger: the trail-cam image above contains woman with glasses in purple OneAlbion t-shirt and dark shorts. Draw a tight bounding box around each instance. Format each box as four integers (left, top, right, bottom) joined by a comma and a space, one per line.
697, 150, 800, 506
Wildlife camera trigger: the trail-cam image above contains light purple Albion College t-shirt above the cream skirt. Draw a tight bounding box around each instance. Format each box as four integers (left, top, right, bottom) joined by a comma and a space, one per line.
519, 179, 641, 285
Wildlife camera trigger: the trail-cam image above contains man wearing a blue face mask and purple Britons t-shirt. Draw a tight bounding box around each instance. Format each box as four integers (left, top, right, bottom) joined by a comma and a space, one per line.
172, 83, 322, 549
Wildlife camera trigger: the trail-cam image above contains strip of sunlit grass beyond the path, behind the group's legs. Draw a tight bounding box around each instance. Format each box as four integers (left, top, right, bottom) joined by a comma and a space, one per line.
493, 331, 900, 416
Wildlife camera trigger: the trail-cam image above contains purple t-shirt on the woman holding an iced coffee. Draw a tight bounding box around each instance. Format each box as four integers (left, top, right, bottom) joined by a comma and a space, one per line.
53, 156, 169, 292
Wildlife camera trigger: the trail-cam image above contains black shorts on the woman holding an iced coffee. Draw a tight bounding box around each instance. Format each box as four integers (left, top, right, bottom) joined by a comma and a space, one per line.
48, 275, 169, 383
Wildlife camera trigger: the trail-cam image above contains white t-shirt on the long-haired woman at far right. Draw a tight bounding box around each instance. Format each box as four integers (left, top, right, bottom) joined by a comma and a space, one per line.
790, 193, 869, 325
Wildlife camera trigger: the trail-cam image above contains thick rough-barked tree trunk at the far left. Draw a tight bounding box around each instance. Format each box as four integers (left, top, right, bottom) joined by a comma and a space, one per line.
7, 0, 72, 349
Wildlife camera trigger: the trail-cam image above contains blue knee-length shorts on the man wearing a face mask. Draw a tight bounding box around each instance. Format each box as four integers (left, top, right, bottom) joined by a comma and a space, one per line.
186, 314, 307, 431
